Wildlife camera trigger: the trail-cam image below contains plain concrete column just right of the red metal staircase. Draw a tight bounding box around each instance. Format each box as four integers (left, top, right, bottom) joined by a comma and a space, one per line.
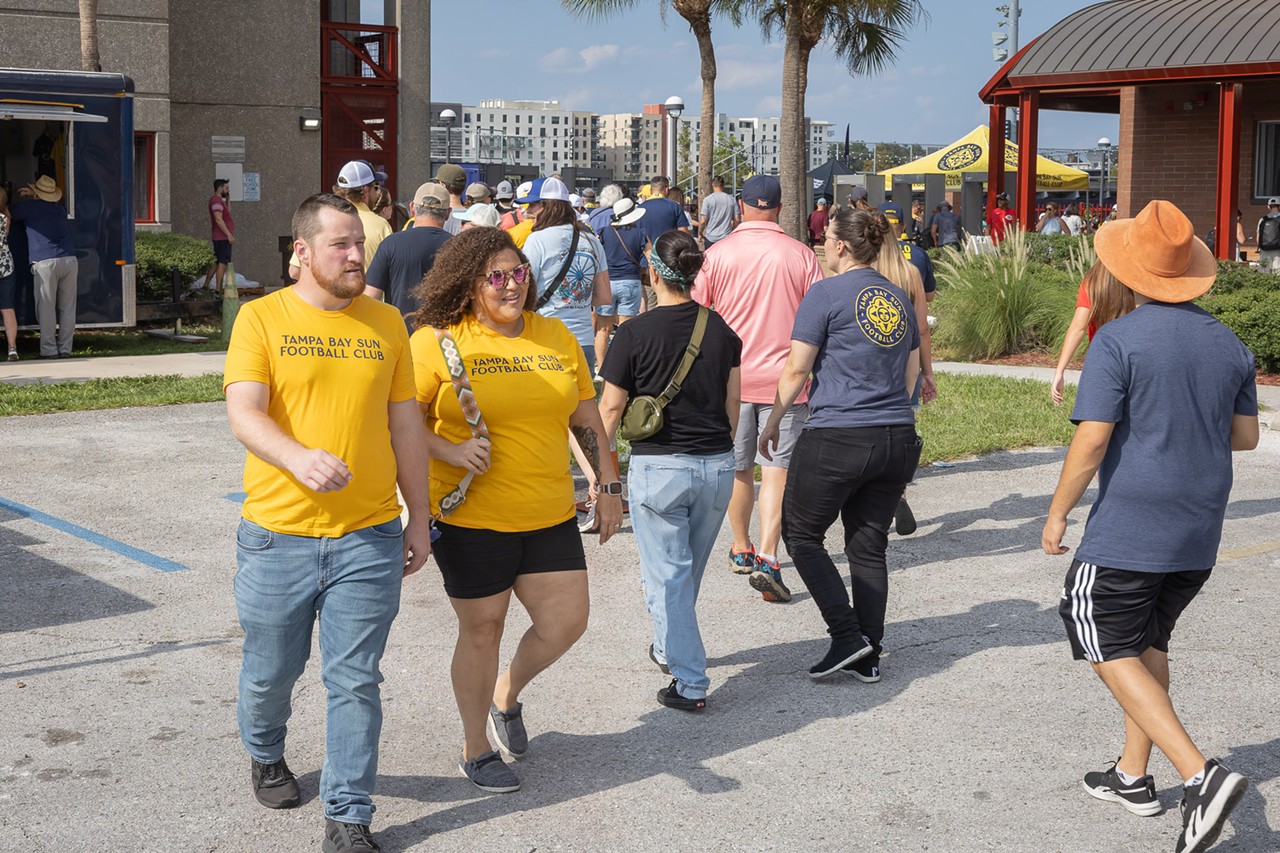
388, 0, 432, 199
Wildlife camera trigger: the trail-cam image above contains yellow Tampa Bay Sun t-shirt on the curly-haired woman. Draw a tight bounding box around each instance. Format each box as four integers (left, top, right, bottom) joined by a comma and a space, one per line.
410, 311, 595, 533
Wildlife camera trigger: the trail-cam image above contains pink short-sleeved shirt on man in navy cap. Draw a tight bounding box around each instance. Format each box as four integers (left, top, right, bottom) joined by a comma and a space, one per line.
692, 222, 823, 405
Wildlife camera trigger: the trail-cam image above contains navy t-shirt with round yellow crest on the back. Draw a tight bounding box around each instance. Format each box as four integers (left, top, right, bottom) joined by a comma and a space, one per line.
791, 269, 920, 429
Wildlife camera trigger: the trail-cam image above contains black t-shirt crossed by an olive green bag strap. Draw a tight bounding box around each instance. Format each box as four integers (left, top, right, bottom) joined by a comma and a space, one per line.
600, 302, 742, 456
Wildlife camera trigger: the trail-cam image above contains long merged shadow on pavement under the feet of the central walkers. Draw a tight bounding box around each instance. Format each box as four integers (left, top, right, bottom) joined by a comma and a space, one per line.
378, 599, 1061, 850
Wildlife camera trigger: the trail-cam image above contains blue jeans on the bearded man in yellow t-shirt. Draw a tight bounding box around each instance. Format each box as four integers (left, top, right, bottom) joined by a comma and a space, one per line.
236, 519, 404, 826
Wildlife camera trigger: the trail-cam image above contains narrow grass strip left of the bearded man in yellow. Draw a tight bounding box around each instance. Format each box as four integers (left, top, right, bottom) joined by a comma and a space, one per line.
0, 373, 223, 415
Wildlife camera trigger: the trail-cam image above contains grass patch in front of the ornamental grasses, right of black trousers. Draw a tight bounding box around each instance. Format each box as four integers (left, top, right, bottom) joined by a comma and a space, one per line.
916, 373, 1075, 465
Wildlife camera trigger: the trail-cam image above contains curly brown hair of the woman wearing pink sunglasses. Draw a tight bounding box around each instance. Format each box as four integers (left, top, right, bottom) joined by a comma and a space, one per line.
412, 228, 538, 329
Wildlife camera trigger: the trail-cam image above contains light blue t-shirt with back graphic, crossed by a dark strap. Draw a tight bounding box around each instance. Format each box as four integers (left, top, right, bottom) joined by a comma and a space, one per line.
525, 225, 608, 350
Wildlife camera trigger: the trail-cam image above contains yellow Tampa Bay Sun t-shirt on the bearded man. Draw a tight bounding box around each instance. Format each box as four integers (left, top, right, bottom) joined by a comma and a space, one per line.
223, 287, 413, 537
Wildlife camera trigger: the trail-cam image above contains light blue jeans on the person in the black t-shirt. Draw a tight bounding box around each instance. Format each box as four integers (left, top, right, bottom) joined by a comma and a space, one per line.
627, 452, 733, 699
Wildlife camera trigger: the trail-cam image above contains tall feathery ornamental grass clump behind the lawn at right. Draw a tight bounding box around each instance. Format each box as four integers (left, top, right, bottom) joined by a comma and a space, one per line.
933, 227, 1079, 359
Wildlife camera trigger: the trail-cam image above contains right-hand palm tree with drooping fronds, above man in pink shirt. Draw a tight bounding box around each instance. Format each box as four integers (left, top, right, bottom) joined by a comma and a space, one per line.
735, 0, 928, 241
